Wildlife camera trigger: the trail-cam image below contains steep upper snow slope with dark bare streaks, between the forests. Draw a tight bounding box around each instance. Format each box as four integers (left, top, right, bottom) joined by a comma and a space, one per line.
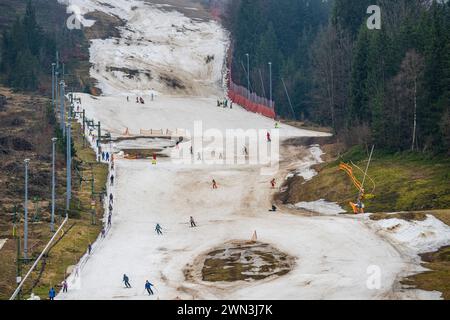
59, 0, 228, 97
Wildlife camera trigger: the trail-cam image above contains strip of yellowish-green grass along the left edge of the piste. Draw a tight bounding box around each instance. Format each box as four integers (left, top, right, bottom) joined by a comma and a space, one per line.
24, 123, 108, 298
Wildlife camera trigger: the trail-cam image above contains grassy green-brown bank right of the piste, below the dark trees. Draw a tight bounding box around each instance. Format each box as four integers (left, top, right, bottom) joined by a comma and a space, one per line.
287, 147, 450, 212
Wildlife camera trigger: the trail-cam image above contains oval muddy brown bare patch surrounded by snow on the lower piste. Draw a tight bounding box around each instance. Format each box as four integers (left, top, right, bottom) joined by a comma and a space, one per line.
185, 241, 295, 282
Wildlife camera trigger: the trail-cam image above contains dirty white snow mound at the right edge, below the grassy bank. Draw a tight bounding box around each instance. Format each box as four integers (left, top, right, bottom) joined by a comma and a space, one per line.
375, 215, 450, 253
